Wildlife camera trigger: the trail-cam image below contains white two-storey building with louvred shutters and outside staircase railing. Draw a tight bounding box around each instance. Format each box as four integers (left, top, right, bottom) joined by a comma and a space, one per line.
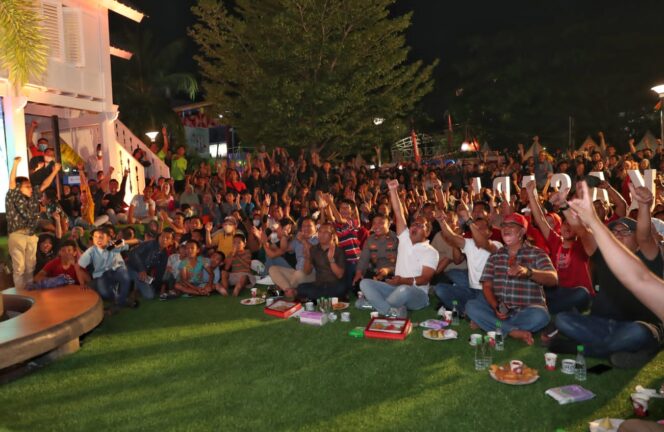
0, 0, 169, 212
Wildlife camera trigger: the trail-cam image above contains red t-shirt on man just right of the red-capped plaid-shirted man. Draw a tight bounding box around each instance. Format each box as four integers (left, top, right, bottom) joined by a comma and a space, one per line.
547, 230, 595, 296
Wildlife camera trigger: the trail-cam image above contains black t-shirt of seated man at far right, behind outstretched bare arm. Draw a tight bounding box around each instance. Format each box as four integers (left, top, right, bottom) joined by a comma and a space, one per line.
590, 249, 664, 324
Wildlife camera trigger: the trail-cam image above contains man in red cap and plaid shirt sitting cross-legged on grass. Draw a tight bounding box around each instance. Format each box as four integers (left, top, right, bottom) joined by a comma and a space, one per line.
466, 213, 558, 345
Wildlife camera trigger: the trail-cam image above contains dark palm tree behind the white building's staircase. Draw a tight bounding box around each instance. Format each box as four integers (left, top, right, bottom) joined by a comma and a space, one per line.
113, 29, 198, 147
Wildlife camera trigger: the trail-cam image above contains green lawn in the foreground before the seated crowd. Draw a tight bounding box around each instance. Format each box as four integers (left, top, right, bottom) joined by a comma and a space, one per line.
0, 296, 664, 431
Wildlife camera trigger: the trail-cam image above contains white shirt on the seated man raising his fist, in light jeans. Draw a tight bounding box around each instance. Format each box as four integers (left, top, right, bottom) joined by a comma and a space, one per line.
394, 229, 438, 294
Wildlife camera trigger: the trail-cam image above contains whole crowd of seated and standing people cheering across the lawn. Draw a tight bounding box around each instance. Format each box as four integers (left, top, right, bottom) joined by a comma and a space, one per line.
6, 131, 664, 382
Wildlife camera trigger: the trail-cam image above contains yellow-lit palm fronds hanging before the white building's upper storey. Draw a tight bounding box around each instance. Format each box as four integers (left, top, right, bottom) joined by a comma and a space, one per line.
0, 0, 48, 91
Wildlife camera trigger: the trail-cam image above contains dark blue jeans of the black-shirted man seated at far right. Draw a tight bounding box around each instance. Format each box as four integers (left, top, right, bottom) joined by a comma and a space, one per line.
556, 312, 657, 357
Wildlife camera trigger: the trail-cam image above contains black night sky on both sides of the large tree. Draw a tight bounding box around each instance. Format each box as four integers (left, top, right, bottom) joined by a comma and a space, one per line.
111, 0, 664, 131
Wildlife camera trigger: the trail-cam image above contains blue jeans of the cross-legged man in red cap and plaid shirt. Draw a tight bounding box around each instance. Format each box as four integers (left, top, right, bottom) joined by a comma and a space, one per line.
466, 294, 550, 335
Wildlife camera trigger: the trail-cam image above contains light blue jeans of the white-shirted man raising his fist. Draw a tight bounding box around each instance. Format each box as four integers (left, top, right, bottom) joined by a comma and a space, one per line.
360, 279, 429, 315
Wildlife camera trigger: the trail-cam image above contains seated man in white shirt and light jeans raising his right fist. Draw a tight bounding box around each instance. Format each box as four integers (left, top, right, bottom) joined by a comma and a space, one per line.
360, 180, 438, 318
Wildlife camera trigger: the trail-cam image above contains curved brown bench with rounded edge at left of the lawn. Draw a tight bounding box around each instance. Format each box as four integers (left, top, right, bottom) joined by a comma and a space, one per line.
0, 286, 104, 369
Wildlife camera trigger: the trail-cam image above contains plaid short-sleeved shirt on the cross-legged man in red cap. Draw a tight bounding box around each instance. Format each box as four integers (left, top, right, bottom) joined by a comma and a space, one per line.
480, 244, 555, 310
